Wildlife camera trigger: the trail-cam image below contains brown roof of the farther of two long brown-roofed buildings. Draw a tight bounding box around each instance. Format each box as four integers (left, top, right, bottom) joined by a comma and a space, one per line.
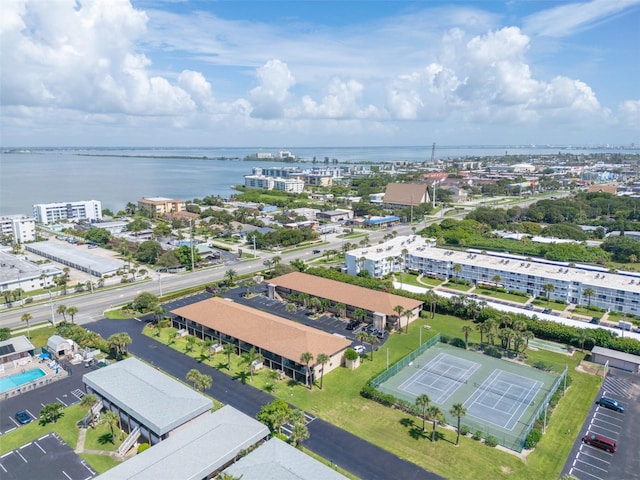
269, 272, 424, 316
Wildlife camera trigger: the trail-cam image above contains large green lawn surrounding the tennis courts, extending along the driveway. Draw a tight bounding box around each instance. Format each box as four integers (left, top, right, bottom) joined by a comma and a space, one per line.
142, 315, 601, 480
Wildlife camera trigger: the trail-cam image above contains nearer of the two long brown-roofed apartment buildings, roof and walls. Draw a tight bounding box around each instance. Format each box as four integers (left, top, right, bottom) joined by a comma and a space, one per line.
171, 297, 351, 382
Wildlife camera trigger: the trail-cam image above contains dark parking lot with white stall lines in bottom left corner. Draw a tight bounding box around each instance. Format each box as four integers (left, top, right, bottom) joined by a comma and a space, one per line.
0, 433, 96, 480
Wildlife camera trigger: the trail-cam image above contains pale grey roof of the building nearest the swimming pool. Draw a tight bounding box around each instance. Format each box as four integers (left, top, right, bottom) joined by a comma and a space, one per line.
82, 358, 213, 436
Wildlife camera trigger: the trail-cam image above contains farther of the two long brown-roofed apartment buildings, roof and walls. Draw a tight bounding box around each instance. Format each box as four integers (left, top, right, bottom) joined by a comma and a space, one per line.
268, 272, 423, 329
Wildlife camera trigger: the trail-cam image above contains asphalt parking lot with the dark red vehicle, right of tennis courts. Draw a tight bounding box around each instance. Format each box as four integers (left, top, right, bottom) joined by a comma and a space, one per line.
563, 369, 640, 480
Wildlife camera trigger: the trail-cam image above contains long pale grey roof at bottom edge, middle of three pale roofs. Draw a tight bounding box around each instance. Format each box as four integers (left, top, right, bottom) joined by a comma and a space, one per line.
96, 405, 268, 480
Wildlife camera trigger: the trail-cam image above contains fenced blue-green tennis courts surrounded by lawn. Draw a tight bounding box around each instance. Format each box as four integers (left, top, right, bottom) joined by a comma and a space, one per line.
371, 339, 566, 451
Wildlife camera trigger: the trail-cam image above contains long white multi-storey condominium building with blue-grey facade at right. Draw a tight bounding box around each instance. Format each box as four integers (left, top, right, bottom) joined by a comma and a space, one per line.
346, 235, 640, 315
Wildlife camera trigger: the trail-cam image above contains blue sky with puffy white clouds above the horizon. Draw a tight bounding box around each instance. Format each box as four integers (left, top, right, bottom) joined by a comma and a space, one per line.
0, 0, 640, 147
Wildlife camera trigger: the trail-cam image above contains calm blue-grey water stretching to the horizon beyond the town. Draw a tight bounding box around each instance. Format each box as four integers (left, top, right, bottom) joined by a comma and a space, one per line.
0, 146, 622, 215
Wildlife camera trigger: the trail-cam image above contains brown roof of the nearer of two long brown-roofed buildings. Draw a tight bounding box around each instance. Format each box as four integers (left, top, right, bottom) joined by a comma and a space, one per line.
171, 297, 351, 362
